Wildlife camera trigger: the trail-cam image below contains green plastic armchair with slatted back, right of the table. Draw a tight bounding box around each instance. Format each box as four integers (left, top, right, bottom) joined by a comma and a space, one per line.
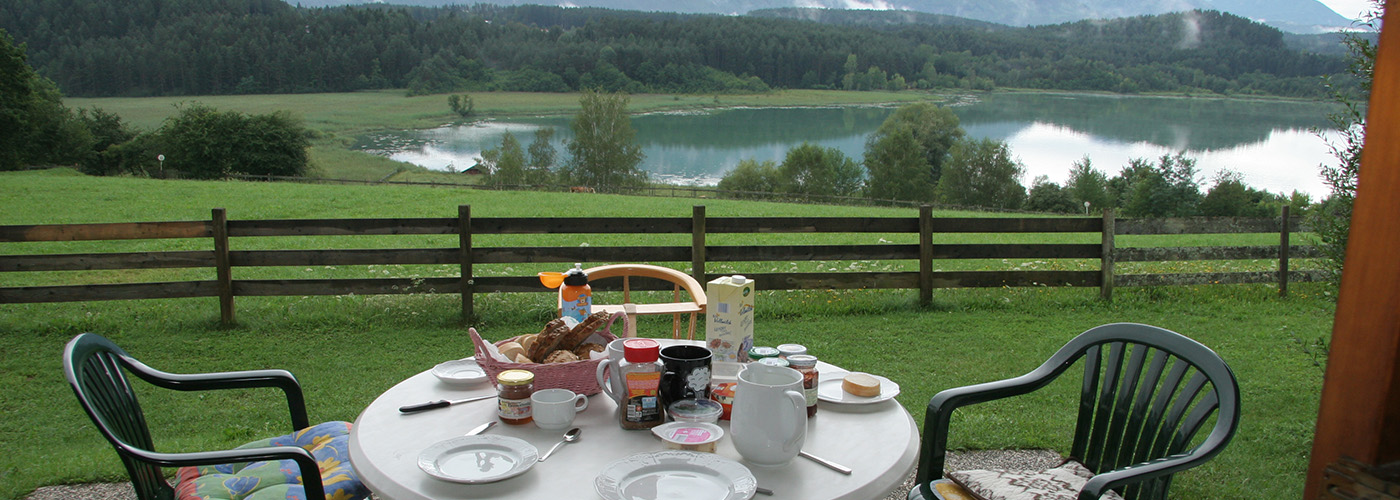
909, 324, 1239, 500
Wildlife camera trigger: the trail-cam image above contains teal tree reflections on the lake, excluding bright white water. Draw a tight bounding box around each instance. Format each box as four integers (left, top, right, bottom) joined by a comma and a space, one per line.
358, 94, 1336, 174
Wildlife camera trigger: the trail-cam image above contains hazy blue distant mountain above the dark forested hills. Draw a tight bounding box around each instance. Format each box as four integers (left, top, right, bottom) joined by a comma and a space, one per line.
287, 0, 1351, 34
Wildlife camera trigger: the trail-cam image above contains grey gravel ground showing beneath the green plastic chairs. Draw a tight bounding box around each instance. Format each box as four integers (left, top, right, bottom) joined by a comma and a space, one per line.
25, 450, 1061, 500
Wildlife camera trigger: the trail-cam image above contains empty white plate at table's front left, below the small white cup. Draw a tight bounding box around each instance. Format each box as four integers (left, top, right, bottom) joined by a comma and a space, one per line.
419, 436, 539, 485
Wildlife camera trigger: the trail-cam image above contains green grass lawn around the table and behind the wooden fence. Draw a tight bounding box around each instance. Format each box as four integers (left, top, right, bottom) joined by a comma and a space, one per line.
0, 171, 1334, 499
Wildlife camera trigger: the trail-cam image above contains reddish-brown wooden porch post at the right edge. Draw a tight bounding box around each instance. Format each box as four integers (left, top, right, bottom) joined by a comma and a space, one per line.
1303, 0, 1400, 499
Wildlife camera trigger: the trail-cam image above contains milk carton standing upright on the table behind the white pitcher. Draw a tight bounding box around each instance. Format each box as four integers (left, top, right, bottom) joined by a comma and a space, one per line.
704, 276, 755, 363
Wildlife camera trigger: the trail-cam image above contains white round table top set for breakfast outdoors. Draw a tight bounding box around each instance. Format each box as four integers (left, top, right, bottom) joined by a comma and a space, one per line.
350, 339, 918, 500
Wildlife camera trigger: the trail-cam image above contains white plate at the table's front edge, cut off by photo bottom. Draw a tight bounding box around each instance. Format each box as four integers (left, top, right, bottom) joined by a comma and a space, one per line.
594, 451, 759, 500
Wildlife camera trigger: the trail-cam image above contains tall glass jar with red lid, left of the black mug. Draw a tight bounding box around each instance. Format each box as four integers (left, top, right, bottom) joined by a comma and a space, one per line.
617, 339, 666, 430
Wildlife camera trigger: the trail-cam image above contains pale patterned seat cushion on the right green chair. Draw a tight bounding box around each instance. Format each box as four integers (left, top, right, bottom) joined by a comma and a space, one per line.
948, 461, 1123, 500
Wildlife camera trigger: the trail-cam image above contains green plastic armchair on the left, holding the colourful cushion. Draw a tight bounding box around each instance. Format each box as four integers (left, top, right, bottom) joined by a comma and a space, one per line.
63, 333, 326, 500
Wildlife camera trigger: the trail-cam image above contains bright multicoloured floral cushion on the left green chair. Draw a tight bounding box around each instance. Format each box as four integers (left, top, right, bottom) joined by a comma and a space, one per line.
175, 422, 370, 500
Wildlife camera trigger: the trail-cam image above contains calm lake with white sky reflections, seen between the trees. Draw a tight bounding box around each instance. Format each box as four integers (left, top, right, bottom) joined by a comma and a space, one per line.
356, 94, 1340, 200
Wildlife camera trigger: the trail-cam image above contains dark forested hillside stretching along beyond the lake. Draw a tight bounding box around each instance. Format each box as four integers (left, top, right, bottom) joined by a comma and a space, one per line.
0, 0, 1352, 97
